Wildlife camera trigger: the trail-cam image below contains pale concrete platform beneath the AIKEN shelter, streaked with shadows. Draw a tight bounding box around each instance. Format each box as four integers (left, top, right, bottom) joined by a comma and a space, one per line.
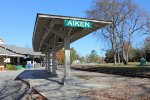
18, 69, 109, 100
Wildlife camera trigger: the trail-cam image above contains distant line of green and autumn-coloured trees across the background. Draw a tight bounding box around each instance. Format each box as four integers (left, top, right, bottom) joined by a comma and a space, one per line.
56, 37, 150, 64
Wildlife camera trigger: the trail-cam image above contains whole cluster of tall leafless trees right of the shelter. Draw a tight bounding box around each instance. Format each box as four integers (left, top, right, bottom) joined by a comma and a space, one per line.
86, 0, 148, 64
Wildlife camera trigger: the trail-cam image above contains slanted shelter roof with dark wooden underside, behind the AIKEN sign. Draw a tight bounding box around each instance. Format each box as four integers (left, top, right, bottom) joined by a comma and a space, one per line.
32, 14, 111, 52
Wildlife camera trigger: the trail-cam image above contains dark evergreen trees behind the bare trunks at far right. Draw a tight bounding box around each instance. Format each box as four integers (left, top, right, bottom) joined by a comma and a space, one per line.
105, 37, 150, 63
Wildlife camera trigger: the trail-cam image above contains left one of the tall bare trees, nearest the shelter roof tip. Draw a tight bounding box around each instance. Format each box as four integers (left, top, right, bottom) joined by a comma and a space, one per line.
87, 0, 128, 65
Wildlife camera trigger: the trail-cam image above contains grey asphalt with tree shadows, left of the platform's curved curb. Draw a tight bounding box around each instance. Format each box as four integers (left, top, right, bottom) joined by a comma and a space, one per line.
0, 70, 27, 100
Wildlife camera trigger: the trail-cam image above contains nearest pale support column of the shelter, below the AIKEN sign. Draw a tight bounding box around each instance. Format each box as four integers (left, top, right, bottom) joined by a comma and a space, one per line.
63, 29, 71, 85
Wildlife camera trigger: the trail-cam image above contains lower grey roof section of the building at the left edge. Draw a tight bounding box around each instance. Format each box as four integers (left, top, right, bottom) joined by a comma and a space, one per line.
0, 47, 25, 57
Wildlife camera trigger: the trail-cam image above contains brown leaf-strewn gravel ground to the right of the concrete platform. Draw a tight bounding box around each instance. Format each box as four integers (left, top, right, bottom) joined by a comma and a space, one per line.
73, 66, 150, 100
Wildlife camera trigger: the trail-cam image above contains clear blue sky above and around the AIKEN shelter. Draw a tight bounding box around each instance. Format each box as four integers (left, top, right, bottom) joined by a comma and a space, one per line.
0, 0, 150, 55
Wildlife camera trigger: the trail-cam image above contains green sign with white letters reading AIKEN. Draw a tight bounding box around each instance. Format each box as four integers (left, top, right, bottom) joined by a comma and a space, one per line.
64, 19, 92, 28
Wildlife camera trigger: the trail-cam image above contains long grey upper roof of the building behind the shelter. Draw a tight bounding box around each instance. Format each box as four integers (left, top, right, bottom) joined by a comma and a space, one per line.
0, 44, 44, 56
